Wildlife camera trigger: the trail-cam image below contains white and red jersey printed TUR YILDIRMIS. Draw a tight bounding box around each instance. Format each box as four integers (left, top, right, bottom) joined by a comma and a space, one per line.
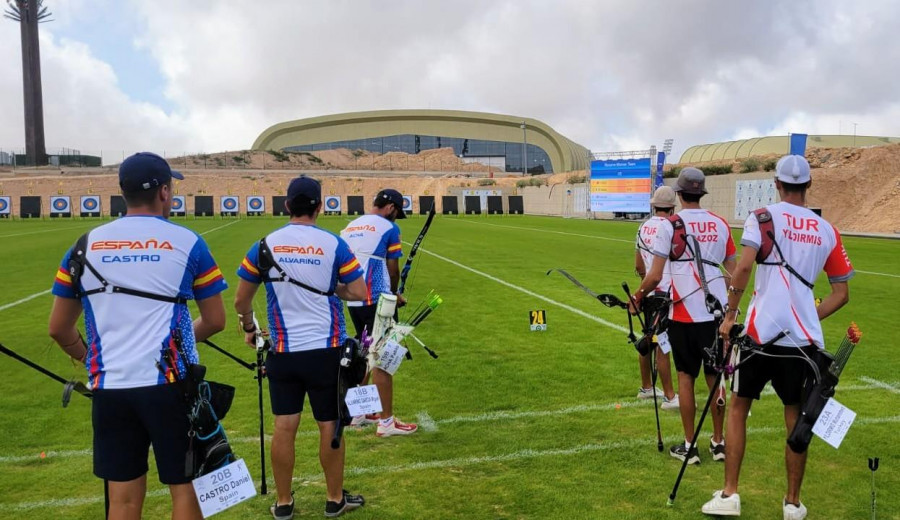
741, 202, 854, 348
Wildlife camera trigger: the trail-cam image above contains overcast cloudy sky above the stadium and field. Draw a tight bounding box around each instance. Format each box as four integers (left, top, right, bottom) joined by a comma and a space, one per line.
0, 0, 900, 159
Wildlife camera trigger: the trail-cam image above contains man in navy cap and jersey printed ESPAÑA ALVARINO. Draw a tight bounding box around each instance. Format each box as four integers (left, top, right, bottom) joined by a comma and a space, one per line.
234, 177, 366, 520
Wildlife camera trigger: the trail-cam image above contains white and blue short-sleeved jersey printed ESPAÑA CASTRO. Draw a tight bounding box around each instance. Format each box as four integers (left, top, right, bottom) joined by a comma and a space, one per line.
53, 216, 227, 389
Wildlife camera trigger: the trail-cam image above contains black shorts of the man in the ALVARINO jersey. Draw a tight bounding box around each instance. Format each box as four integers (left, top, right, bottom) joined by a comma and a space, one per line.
266, 348, 341, 422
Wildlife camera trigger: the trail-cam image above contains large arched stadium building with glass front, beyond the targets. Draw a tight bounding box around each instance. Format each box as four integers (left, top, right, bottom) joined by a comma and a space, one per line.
253, 110, 590, 174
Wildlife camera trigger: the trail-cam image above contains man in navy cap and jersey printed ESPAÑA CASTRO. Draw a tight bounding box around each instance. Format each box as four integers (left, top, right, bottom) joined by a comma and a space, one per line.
49, 152, 227, 519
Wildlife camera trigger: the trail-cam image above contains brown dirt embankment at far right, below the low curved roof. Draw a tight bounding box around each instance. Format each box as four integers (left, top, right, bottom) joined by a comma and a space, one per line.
681, 144, 900, 233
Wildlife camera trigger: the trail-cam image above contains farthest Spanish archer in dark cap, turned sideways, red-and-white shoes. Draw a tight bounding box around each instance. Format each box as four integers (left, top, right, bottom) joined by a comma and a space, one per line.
341, 189, 418, 437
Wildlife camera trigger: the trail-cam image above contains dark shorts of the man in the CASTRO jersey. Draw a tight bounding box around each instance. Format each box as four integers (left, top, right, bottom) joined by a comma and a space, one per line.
91, 385, 191, 485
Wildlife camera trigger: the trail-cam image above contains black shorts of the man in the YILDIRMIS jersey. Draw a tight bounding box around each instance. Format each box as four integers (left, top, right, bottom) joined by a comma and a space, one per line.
731, 345, 817, 405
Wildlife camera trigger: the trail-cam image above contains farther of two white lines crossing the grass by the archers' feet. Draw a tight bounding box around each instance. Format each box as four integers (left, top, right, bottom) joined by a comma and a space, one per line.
0, 376, 884, 463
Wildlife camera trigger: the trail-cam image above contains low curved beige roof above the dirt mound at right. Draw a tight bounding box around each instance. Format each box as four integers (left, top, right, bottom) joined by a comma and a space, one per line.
678, 135, 900, 163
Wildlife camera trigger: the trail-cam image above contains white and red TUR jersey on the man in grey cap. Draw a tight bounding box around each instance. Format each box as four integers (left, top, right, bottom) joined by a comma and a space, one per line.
652, 209, 735, 323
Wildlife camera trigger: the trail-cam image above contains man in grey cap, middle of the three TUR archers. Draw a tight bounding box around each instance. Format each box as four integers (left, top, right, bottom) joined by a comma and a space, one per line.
634, 167, 735, 464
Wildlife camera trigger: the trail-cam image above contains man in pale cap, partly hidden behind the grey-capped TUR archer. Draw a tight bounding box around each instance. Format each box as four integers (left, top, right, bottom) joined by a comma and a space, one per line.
634, 186, 678, 410
